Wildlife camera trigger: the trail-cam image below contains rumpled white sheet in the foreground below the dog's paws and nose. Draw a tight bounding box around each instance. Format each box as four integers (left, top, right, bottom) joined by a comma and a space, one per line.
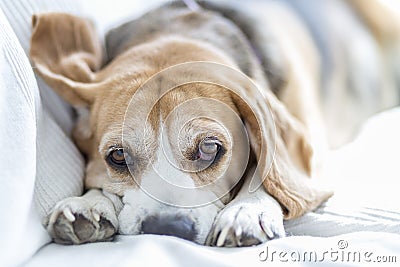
26, 232, 400, 267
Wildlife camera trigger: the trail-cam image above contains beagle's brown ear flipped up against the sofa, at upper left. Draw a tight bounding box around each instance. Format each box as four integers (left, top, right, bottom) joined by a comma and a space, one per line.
30, 13, 102, 106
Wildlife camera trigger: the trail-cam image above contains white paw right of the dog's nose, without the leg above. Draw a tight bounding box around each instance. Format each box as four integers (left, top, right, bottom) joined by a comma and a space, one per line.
207, 203, 285, 247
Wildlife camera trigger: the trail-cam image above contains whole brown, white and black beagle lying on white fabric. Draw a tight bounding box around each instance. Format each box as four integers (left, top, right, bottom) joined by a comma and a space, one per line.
30, 0, 399, 247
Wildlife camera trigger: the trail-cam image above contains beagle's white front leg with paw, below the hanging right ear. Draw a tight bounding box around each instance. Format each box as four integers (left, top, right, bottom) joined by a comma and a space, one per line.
206, 171, 285, 247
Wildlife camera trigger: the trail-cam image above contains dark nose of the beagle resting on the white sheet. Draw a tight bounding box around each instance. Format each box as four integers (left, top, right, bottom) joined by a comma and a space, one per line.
141, 214, 197, 241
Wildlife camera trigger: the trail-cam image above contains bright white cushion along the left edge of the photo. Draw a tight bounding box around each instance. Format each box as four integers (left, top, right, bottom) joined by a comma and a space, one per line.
0, 10, 48, 266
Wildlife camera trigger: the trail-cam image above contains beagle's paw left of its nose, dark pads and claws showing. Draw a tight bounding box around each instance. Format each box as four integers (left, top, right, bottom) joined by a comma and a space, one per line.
47, 197, 118, 244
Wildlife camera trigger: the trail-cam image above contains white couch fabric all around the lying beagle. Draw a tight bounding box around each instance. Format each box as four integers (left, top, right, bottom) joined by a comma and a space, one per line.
0, 0, 400, 267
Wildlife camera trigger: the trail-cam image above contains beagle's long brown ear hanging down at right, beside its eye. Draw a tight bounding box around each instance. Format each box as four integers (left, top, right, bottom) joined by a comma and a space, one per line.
234, 91, 332, 219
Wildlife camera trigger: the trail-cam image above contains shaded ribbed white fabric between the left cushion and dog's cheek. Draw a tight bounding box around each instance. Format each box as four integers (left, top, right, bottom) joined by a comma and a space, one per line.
34, 107, 84, 218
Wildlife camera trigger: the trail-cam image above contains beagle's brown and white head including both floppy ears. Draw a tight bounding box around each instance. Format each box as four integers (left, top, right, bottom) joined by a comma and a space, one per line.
31, 13, 329, 243
